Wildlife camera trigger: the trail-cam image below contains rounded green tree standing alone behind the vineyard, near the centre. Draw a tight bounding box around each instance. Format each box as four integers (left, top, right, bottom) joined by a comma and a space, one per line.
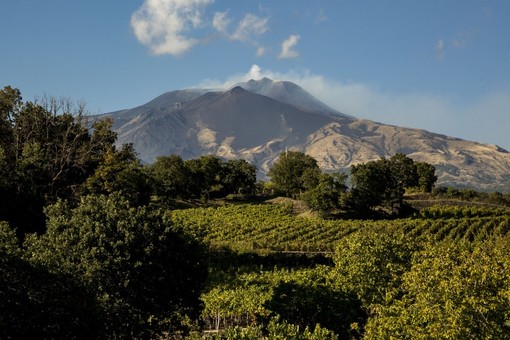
268, 151, 321, 197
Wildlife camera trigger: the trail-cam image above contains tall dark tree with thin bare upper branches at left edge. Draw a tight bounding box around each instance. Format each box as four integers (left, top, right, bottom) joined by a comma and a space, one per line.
0, 86, 119, 234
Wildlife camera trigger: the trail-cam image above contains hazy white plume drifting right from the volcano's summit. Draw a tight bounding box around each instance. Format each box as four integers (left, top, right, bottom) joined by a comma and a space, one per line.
194, 65, 510, 149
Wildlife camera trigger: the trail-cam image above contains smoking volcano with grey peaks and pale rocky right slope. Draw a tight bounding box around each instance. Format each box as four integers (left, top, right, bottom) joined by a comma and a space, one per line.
102, 78, 510, 189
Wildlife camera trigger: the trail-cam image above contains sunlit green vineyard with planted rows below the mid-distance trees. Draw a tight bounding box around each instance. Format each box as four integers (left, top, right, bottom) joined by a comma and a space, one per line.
171, 204, 510, 252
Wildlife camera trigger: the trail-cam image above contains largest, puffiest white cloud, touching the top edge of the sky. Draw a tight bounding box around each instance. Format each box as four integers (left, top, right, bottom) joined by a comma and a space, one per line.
131, 0, 213, 56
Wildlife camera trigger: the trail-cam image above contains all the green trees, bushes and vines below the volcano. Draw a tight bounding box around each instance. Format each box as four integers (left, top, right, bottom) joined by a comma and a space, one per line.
0, 87, 510, 339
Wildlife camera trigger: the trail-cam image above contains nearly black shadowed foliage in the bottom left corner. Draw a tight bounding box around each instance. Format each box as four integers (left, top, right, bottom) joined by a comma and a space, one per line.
0, 222, 102, 339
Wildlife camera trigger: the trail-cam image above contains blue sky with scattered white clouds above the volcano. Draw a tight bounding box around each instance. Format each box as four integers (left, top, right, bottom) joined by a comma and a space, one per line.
0, 0, 510, 149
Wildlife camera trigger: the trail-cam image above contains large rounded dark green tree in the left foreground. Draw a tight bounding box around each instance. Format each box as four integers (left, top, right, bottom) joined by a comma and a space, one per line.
26, 193, 207, 338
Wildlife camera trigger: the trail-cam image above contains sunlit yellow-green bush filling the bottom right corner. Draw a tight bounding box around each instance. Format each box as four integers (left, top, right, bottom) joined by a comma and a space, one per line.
365, 237, 510, 339
